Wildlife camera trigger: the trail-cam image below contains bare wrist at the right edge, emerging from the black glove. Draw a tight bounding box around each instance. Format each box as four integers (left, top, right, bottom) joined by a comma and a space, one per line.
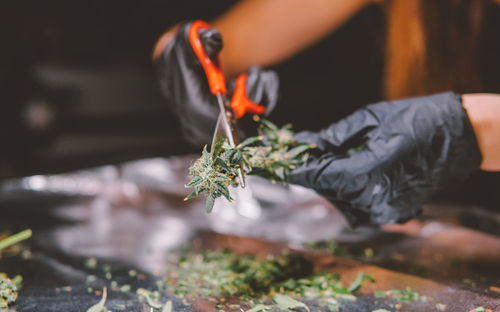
462, 93, 500, 171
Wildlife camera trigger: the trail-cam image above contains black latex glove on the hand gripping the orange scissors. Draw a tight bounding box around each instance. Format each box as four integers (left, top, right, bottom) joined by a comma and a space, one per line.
155, 22, 279, 146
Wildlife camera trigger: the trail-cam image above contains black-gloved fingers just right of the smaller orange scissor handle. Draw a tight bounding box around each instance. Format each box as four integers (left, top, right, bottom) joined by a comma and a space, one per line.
247, 66, 279, 116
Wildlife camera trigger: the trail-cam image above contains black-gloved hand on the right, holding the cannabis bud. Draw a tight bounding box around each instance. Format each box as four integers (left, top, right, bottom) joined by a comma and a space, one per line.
291, 92, 481, 225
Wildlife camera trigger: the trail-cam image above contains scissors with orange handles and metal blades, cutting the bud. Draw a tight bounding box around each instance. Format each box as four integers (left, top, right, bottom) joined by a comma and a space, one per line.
188, 20, 266, 187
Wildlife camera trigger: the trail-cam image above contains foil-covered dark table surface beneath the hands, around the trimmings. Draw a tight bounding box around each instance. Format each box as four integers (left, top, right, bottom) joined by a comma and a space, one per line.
0, 157, 500, 311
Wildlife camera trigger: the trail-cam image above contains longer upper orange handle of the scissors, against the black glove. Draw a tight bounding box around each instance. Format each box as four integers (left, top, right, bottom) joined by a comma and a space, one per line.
188, 20, 227, 95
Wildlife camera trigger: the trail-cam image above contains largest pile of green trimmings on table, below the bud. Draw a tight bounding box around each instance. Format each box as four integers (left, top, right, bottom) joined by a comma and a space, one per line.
164, 250, 373, 311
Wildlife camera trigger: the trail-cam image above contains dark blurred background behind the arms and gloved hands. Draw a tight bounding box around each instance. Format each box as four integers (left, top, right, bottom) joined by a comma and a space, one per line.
0, 0, 500, 207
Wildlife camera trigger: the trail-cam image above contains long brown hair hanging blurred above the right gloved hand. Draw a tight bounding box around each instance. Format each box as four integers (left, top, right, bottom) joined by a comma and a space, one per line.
384, 0, 489, 99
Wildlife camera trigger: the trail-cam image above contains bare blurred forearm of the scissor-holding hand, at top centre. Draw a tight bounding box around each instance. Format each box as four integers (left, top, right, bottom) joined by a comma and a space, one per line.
153, 0, 373, 77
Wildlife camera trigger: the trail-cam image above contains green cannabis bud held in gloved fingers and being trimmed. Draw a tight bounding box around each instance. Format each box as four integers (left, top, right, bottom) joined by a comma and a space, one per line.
186, 119, 313, 213
